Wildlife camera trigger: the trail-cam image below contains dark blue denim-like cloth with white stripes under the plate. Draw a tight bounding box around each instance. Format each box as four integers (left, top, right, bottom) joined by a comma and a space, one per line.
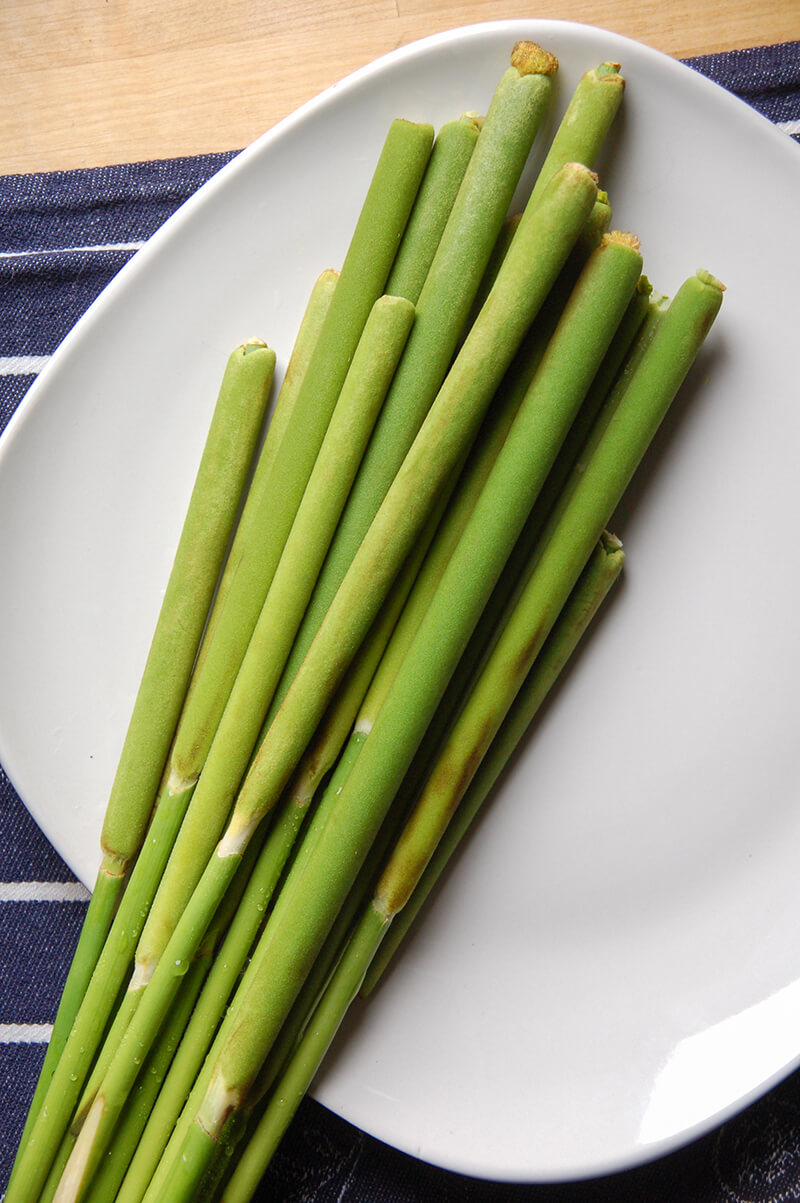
0, 42, 800, 1203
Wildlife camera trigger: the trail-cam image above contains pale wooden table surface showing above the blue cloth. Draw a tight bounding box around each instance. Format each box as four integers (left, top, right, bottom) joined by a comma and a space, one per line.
0, 0, 800, 174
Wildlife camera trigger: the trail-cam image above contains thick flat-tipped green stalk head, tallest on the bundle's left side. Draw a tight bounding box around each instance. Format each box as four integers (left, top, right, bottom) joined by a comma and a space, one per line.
164, 120, 433, 792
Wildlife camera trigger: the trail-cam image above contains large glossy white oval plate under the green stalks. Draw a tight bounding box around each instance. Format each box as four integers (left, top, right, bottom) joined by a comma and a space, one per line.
0, 20, 800, 1180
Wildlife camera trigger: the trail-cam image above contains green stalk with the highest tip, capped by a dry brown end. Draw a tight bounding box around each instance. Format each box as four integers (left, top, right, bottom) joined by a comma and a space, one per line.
262, 43, 557, 721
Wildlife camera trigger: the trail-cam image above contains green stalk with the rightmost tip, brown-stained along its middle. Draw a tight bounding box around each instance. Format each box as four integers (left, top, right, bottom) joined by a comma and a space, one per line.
218, 273, 722, 1203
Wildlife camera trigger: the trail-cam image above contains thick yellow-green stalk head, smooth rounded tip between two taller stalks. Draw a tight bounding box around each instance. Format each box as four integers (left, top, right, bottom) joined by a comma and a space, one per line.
131, 288, 414, 990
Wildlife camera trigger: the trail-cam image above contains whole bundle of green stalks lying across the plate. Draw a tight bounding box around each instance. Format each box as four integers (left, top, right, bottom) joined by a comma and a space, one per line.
6, 43, 722, 1203
